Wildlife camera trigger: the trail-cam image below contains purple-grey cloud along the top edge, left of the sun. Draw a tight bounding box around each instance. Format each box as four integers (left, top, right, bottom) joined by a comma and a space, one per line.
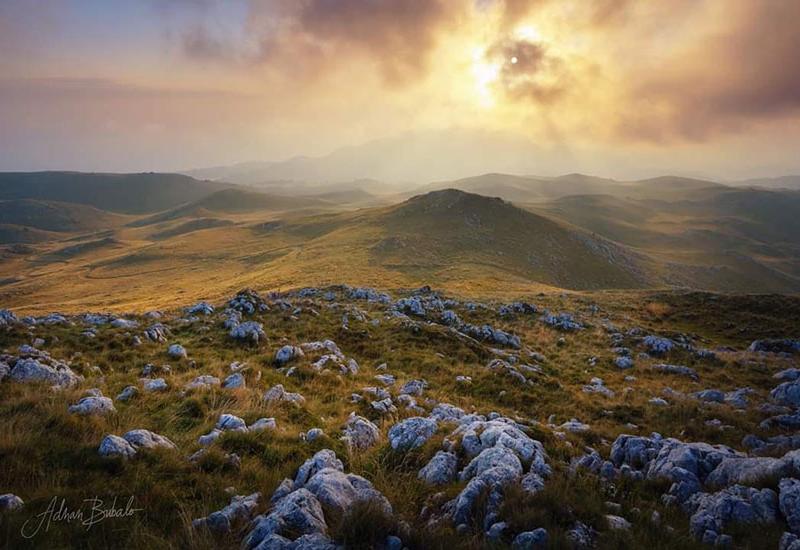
170, 0, 460, 85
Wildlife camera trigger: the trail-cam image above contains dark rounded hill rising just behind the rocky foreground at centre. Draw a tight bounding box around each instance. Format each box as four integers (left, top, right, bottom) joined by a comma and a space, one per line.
370, 189, 647, 289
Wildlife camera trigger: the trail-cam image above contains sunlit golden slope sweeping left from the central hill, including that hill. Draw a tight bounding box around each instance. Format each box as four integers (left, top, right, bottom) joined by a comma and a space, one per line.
0, 190, 652, 311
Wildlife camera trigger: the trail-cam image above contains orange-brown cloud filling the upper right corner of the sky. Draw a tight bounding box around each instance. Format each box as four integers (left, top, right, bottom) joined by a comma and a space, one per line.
618, 0, 800, 141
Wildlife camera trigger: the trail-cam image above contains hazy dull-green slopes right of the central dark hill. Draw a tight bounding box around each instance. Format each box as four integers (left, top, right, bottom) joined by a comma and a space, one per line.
529, 186, 800, 292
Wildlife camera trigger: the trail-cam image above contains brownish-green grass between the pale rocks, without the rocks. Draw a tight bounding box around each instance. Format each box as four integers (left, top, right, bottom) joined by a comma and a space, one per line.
0, 293, 800, 549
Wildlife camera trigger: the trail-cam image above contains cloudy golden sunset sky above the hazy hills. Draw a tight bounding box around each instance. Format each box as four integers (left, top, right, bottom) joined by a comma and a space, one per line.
0, 0, 800, 179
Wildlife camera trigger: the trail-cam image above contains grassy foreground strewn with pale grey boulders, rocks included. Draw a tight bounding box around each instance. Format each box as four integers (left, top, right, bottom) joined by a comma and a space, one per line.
0, 286, 800, 550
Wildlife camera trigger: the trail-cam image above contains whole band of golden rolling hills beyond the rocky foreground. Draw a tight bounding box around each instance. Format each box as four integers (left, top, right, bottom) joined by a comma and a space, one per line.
0, 182, 800, 309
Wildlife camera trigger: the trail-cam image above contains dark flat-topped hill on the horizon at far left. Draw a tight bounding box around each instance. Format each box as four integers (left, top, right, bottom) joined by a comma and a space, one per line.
0, 172, 230, 214
